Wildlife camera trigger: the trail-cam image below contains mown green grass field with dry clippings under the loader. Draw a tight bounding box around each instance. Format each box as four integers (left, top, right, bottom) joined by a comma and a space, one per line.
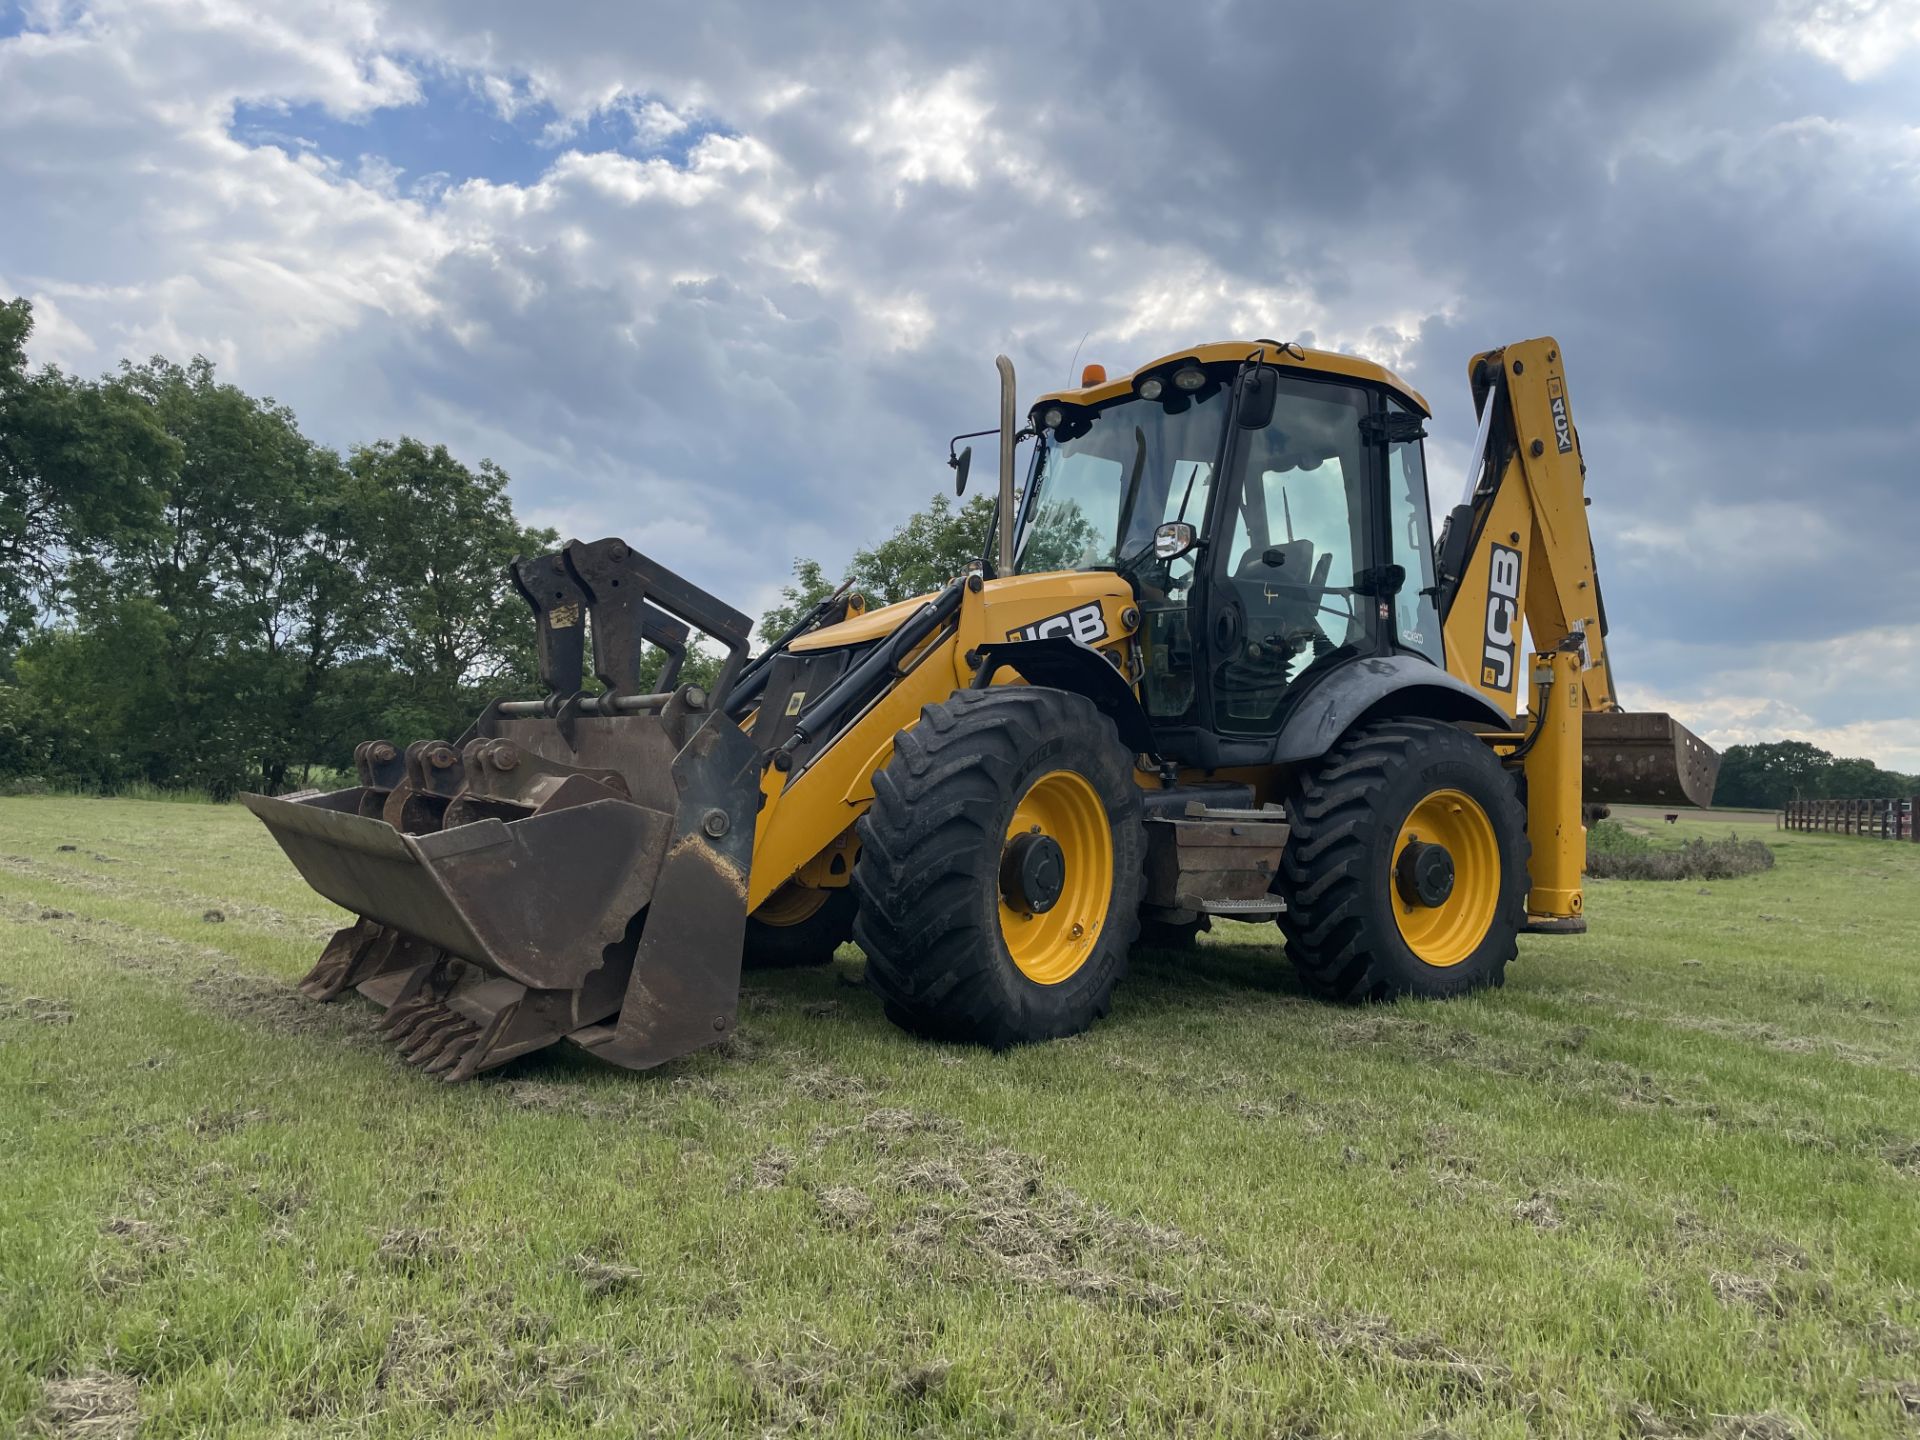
0, 799, 1920, 1438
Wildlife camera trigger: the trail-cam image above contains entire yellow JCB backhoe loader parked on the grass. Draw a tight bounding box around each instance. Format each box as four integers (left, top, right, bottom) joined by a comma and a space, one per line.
248, 340, 1718, 1079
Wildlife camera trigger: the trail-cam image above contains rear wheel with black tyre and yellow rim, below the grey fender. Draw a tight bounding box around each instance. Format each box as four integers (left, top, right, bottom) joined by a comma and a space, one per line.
1275, 720, 1530, 1000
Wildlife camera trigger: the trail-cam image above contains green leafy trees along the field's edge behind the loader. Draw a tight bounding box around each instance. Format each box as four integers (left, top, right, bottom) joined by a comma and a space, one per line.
0, 300, 1920, 808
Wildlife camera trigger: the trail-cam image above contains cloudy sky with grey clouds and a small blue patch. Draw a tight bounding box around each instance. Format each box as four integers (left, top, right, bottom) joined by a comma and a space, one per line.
0, 0, 1920, 770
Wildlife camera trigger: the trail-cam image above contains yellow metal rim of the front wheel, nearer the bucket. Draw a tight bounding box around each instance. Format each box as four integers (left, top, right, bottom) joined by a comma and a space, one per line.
1000, 770, 1114, 985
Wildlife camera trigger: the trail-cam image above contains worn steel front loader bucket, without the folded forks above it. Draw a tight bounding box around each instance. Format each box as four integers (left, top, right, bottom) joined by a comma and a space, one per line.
244, 714, 758, 1079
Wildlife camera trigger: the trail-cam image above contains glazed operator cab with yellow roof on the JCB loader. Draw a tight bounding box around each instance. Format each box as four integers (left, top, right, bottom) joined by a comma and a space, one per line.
1014, 340, 1442, 758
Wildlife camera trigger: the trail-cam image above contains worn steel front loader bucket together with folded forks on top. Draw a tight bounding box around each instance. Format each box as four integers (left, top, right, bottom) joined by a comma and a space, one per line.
242, 540, 760, 1079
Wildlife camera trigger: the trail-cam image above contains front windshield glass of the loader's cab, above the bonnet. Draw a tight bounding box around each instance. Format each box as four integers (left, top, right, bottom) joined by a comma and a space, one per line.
1014, 382, 1227, 574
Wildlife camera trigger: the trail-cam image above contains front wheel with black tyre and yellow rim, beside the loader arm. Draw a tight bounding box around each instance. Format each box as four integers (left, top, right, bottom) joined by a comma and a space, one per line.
852, 685, 1146, 1050
